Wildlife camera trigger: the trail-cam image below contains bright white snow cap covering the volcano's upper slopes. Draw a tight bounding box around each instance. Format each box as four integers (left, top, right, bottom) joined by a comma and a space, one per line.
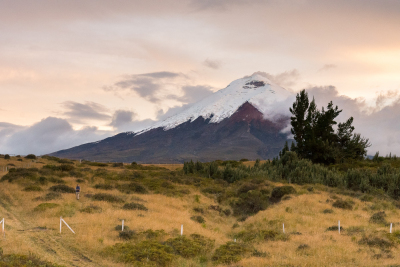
138, 74, 293, 134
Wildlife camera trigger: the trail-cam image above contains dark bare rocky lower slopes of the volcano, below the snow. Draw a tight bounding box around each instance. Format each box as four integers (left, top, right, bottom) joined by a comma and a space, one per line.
51, 102, 289, 163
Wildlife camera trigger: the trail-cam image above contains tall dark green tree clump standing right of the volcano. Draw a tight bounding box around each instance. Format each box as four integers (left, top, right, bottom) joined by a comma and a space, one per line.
284, 90, 371, 165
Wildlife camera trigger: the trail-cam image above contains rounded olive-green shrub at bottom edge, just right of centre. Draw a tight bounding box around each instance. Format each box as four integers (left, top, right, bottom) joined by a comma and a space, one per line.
211, 242, 250, 264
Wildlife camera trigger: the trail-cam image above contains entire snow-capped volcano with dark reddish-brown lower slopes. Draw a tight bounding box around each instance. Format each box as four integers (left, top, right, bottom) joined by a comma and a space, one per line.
51, 74, 293, 163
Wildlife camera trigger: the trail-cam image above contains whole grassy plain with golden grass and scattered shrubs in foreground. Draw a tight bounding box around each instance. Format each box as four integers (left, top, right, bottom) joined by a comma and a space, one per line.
0, 157, 400, 267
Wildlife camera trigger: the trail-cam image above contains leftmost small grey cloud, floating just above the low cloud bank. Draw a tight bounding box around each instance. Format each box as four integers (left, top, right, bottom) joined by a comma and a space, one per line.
62, 101, 111, 123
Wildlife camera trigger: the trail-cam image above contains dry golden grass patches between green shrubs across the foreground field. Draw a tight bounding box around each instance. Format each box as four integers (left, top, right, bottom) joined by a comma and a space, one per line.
0, 159, 400, 267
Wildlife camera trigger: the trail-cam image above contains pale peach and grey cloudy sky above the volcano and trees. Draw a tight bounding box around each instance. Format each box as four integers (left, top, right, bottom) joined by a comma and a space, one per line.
0, 0, 400, 155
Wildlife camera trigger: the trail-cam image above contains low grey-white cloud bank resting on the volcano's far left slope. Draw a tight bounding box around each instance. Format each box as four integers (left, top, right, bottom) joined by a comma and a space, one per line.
0, 117, 112, 155
